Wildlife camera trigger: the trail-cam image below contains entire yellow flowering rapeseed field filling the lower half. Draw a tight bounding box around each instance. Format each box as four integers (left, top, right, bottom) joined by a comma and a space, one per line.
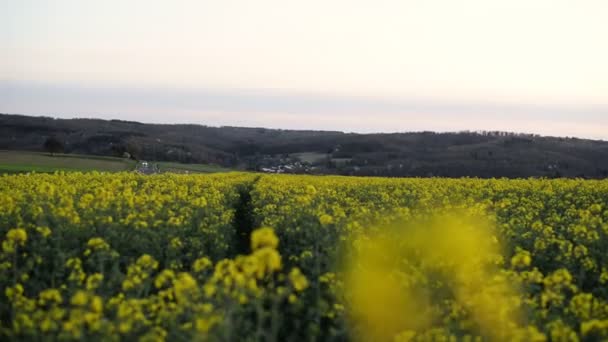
0, 173, 608, 341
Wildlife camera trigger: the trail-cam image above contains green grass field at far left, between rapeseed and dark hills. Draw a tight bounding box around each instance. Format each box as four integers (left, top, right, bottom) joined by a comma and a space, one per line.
0, 151, 135, 173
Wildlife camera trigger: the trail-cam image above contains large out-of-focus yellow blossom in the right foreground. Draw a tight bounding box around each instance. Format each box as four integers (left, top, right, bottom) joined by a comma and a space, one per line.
345, 214, 519, 341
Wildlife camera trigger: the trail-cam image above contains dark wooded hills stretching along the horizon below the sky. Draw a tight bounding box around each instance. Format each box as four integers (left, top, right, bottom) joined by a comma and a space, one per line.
0, 114, 608, 178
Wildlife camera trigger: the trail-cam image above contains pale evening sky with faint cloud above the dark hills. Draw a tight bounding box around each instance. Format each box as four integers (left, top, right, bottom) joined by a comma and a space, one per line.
0, 0, 608, 140
